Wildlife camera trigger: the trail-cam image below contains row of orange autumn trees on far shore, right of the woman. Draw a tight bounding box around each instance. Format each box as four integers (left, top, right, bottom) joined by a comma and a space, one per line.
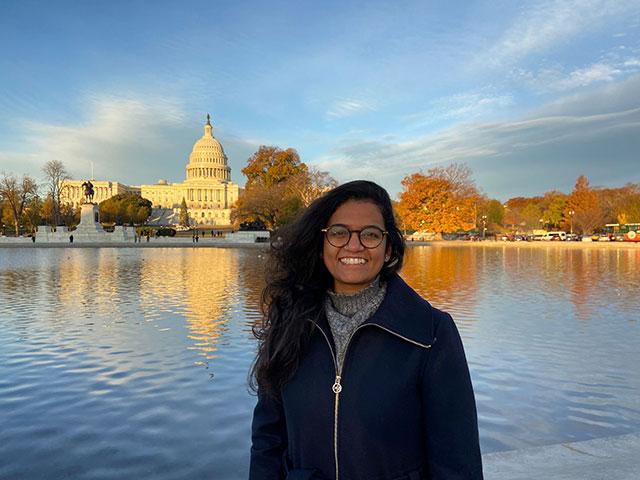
396, 169, 640, 234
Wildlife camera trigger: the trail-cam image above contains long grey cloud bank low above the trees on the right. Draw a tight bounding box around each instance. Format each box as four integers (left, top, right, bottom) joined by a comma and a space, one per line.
315, 77, 640, 197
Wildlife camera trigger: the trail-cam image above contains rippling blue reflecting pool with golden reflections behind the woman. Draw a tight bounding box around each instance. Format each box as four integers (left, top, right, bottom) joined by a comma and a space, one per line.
0, 245, 640, 479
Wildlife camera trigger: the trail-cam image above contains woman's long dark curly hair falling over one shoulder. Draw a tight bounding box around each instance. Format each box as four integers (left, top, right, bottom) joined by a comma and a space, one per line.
249, 180, 405, 397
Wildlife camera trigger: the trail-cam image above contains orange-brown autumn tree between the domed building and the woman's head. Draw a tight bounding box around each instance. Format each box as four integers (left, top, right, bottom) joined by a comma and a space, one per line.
231, 146, 336, 231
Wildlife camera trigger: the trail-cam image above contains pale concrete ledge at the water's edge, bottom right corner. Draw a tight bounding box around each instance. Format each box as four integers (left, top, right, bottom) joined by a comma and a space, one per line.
482, 433, 640, 480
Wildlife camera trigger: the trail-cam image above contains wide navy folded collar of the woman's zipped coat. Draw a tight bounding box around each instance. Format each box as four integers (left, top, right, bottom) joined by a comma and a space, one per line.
316, 273, 435, 348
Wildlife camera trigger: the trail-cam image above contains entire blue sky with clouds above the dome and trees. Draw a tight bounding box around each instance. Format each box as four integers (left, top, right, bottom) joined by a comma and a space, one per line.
0, 0, 640, 201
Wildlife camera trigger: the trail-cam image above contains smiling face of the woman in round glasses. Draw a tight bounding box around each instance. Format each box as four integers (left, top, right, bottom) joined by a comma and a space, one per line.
322, 200, 391, 293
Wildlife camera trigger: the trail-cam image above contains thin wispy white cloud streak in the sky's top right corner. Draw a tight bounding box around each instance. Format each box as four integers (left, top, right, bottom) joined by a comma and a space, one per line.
483, 0, 637, 66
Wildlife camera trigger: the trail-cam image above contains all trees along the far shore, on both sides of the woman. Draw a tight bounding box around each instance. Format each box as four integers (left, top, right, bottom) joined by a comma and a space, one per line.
0, 152, 640, 235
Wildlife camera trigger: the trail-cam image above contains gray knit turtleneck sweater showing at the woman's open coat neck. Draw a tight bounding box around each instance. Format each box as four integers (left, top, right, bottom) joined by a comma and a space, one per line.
324, 277, 387, 371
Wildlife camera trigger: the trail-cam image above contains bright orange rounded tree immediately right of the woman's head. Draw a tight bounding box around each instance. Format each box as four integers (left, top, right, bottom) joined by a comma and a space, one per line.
397, 164, 480, 233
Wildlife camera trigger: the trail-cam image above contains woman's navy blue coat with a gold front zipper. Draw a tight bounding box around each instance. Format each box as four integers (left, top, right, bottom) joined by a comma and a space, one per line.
249, 275, 482, 480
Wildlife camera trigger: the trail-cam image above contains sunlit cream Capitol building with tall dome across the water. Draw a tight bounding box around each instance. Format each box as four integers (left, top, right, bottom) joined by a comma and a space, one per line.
63, 115, 241, 225
